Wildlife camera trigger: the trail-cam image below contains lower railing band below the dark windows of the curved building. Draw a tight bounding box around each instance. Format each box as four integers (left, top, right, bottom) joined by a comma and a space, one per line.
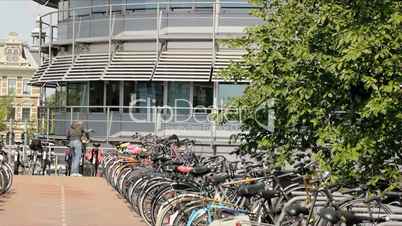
38, 106, 241, 145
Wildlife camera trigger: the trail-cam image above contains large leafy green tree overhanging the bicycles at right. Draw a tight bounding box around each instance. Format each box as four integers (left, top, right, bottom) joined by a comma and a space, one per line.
223, 0, 402, 185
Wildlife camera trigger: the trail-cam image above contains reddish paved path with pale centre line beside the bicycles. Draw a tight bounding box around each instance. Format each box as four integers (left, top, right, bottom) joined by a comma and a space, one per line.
0, 176, 146, 226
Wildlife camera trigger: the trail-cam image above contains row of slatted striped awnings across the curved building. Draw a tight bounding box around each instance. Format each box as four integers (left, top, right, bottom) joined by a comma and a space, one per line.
31, 49, 244, 85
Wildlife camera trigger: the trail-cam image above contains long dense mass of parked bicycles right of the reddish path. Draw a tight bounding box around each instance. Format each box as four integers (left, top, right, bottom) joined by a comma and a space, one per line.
103, 136, 402, 226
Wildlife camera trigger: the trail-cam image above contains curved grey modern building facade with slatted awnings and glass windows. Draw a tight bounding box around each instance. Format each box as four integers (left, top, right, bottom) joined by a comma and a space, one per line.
32, 0, 260, 141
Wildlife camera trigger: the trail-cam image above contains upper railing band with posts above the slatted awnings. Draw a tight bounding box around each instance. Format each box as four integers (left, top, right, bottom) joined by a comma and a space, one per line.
39, 1, 261, 63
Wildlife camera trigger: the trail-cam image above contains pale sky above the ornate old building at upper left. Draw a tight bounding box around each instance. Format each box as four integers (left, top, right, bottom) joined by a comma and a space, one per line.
0, 0, 55, 44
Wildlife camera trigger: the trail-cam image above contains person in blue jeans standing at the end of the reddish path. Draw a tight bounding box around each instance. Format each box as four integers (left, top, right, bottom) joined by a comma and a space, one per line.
67, 121, 84, 176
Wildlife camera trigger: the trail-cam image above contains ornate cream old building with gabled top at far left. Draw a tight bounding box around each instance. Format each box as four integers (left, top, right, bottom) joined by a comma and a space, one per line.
0, 32, 40, 141
